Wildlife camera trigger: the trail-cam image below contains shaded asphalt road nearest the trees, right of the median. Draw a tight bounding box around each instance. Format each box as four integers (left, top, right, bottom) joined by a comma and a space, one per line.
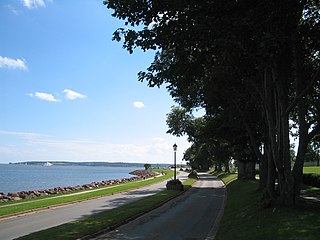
94, 174, 225, 240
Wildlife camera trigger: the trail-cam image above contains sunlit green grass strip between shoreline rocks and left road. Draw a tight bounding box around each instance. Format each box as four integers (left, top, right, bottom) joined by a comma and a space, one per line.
0, 171, 173, 216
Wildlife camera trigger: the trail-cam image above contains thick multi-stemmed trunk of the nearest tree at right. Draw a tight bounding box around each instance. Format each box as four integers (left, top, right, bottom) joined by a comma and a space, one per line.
264, 59, 293, 205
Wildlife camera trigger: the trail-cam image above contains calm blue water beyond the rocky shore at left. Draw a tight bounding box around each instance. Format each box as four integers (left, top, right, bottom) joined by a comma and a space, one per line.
0, 164, 139, 193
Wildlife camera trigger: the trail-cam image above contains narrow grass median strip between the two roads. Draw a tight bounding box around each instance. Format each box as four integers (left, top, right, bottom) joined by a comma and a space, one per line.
19, 179, 196, 240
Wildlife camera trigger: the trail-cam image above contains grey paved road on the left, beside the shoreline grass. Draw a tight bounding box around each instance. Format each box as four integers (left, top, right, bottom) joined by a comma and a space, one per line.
0, 172, 187, 240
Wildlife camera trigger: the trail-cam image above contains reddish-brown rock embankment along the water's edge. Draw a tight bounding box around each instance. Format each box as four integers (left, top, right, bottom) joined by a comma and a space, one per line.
0, 170, 157, 202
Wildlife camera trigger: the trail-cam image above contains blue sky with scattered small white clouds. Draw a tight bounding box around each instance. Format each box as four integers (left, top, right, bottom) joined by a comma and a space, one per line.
0, 0, 190, 164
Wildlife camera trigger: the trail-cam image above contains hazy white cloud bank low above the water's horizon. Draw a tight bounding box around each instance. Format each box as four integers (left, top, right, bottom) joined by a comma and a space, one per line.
0, 130, 189, 164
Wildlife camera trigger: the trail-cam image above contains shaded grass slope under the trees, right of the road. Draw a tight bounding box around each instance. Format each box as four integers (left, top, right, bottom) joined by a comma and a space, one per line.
215, 174, 320, 240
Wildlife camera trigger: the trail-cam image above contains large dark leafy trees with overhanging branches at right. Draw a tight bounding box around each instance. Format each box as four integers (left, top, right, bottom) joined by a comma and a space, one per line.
104, 0, 320, 205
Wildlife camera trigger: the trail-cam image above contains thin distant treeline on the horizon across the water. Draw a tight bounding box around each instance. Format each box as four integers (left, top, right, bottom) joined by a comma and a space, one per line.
10, 161, 170, 168
